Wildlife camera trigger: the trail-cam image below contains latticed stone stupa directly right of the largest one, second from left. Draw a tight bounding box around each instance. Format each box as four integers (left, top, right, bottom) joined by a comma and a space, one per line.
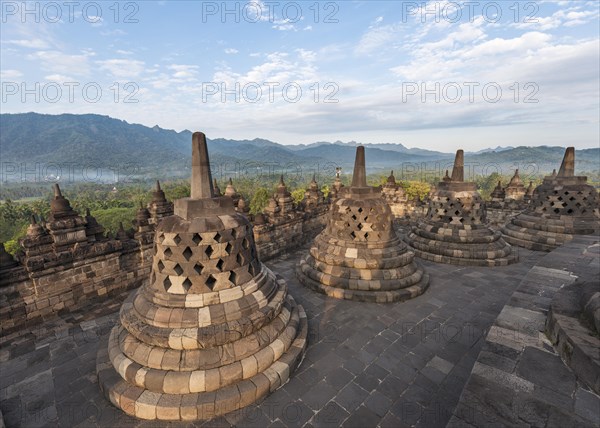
296, 146, 429, 303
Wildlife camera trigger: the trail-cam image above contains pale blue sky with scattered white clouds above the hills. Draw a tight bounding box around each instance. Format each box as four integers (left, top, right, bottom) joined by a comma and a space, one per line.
0, 0, 600, 151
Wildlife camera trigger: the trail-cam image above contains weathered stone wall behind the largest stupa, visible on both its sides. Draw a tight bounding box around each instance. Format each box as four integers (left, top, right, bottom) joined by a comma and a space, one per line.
0, 192, 328, 339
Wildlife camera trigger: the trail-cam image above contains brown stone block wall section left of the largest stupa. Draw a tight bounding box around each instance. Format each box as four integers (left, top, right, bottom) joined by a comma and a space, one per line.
0, 239, 152, 337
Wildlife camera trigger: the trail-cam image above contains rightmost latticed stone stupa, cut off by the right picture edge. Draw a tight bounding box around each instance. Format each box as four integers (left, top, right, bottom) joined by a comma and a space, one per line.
502, 147, 600, 251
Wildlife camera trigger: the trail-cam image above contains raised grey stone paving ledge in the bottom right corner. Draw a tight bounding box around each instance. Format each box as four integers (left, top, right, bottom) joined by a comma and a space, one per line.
448, 236, 600, 427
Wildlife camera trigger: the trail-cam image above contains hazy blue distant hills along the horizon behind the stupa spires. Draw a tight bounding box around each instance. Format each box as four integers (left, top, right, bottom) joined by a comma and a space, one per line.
0, 113, 600, 178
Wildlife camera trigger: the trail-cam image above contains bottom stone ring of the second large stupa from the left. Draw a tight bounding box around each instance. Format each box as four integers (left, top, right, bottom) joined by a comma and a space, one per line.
296, 259, 429, 303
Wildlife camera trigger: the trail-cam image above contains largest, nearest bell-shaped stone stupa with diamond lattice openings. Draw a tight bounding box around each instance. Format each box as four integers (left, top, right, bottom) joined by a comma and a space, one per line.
97, 132, 307, 421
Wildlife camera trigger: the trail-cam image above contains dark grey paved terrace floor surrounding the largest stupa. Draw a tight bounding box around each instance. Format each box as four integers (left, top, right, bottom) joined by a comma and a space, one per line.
0, 241, 544, 427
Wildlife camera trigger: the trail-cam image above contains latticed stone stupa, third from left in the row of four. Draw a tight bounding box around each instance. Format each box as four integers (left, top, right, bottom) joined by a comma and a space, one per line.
406, 150, 517, 266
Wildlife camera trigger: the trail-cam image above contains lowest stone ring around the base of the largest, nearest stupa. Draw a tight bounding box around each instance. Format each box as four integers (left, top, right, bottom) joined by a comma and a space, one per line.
96, 295, 308, 421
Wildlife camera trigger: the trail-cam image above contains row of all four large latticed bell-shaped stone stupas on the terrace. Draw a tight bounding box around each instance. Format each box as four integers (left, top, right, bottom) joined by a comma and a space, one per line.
97, 132, 598, 420
